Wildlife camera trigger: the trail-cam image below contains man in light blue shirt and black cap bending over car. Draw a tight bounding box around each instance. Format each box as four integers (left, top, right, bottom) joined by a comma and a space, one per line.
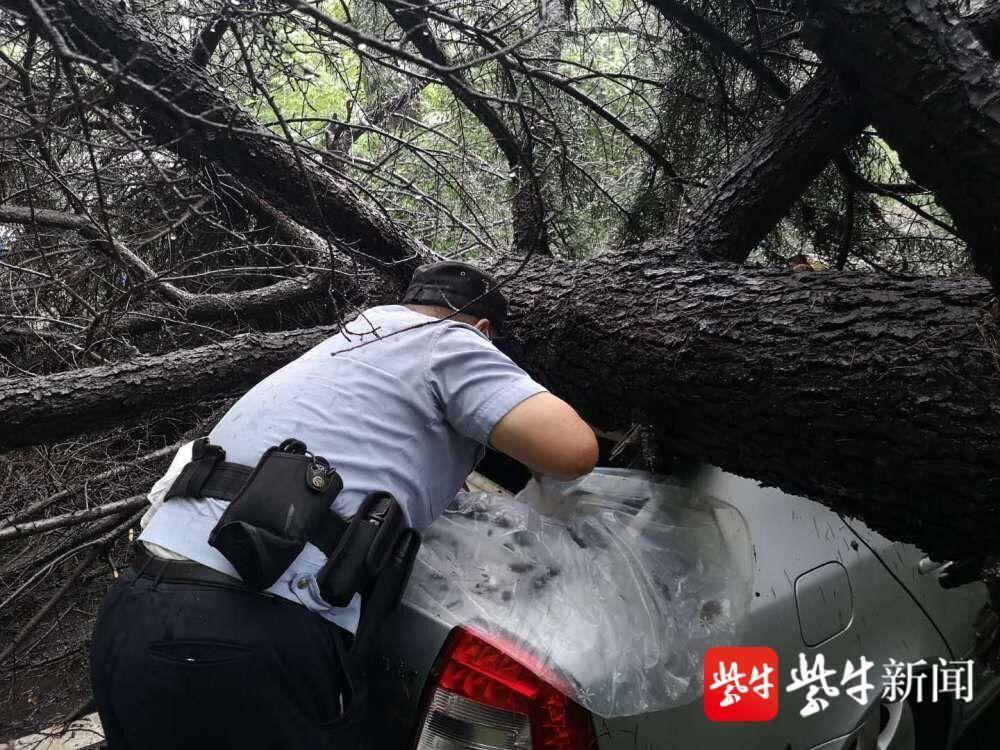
91, 262, 597, 750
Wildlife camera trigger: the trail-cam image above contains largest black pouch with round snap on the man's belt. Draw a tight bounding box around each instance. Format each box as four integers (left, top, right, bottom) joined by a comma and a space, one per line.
208, 441, 344, 590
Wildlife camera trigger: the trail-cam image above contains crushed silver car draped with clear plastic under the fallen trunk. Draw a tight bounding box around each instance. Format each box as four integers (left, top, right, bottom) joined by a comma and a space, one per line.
364, 466, 1000, 750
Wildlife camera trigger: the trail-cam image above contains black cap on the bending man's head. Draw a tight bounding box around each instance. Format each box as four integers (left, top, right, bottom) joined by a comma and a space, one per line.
403, 260, 507, 328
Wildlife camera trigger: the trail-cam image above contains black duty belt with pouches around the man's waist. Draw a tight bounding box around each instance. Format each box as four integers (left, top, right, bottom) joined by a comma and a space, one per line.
159, 438, 420, 619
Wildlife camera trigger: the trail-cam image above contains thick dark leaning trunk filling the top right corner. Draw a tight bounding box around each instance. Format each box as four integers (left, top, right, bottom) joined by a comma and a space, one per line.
803, 0, 1000, 285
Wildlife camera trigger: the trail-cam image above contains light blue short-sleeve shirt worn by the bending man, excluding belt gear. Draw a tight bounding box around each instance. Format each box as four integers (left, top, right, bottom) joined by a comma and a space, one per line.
140, 305, 545, 631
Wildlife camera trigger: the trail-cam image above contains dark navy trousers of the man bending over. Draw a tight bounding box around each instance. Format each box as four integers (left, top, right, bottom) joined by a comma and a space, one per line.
90, 571, 350, 750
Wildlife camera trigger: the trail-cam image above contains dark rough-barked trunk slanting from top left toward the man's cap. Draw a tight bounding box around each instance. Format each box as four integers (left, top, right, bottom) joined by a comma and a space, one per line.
0, 0, 425, 274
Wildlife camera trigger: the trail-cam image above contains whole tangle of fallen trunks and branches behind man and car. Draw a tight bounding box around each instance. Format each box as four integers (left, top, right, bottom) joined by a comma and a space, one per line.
0, 0, 1000, 740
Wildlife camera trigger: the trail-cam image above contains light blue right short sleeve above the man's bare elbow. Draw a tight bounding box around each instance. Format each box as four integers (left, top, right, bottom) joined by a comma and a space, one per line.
428, 324, 545, 445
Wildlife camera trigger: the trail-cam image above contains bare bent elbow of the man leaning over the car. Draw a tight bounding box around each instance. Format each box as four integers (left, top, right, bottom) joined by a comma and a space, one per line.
490, 393, 597, 480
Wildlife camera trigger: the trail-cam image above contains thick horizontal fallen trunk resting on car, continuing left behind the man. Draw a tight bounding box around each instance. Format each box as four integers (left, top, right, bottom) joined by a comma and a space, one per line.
0, 253, 1000, 558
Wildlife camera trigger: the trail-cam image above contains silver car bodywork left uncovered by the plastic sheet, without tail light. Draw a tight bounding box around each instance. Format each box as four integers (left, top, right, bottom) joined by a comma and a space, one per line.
372, 466, 997, 750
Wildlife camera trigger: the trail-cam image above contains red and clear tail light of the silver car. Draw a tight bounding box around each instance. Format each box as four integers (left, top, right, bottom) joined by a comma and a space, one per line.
416, 628, 597, 750
